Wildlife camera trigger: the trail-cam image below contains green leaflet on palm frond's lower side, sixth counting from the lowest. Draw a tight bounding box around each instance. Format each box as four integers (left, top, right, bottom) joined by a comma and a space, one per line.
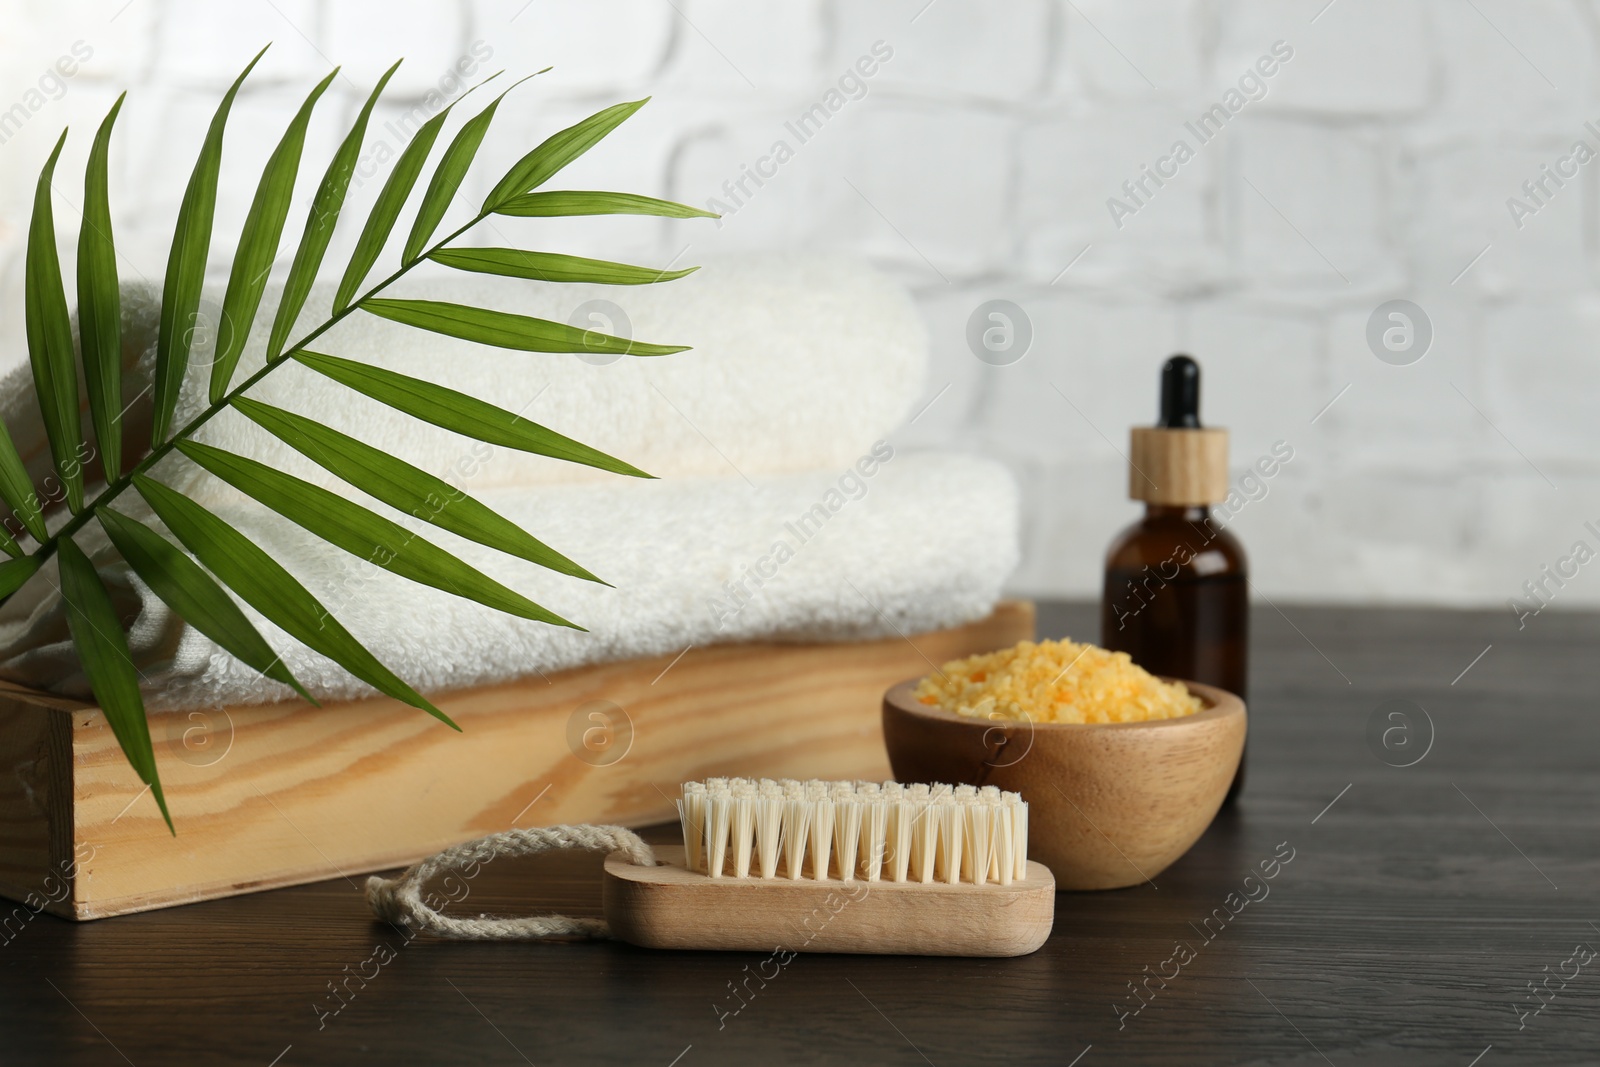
294, 352, 651, 478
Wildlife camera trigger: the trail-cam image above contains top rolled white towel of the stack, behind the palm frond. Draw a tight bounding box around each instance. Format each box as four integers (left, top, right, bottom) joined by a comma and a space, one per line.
0, 256, 928, 502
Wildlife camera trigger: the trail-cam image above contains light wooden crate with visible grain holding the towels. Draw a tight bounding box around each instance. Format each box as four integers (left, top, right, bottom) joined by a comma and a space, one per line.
0, 601, 1034, 936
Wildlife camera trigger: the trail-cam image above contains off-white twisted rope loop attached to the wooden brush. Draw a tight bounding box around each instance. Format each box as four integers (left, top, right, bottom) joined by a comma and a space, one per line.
366, 825, 656, 941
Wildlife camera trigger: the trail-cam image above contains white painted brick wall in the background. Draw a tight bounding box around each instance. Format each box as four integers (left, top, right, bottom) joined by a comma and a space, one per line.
0, 0, 1600, 605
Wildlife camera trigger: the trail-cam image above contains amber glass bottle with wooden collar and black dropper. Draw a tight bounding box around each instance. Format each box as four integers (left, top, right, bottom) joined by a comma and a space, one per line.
1101, 355, 1250, 801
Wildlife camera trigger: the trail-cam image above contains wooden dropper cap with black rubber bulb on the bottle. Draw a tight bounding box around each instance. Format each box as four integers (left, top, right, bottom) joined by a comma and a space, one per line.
1128, 355, 1227, 507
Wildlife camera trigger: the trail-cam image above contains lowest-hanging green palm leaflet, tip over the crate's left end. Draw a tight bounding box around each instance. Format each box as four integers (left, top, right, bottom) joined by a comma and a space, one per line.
56, 537, 178, 833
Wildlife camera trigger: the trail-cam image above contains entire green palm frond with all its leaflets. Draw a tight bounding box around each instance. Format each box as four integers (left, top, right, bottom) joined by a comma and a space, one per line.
0, 50, 714, 827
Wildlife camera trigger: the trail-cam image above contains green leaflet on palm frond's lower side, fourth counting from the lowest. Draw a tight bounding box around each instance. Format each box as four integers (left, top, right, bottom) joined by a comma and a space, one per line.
178, 442, 582, 630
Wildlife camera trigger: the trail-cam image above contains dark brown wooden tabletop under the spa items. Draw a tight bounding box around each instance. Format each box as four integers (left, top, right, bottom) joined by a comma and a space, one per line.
0, 605, 1600, 1067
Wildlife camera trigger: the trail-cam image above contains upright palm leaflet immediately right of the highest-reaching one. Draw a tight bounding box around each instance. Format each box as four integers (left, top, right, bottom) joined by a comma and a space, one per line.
211, 67, 339, 403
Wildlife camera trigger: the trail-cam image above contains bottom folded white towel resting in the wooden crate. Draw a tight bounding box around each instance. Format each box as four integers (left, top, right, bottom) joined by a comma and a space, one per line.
0, 451, 1018, 709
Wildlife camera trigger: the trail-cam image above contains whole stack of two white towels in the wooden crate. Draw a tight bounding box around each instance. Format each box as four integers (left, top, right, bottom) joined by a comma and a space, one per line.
0, 259, 1018, 709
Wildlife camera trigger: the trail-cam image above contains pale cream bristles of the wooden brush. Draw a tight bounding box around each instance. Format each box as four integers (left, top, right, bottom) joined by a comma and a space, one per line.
678, 777, 1027, 885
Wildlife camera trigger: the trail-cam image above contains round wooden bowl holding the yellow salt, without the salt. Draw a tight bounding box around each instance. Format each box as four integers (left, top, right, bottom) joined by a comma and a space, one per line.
883, 678, 1245, 889
